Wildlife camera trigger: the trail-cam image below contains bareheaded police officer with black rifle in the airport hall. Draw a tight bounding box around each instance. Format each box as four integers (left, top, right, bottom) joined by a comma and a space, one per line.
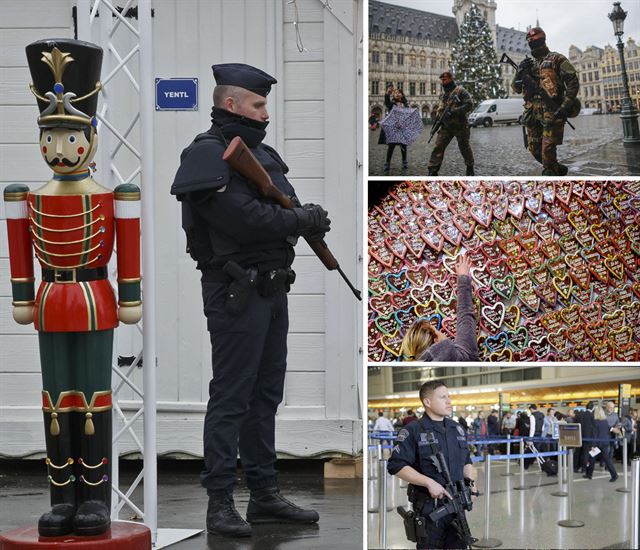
388, 380, 476, 549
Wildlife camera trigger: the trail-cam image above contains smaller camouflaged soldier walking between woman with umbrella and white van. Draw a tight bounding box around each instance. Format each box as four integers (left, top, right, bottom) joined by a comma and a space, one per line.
428, 71, 474, 176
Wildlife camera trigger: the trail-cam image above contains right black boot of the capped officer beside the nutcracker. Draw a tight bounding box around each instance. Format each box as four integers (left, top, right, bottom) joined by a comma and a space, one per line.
247, 487, 320, 523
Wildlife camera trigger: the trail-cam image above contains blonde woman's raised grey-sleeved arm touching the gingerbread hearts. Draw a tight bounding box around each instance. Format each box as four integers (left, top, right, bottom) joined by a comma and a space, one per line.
455, 256, 478, 361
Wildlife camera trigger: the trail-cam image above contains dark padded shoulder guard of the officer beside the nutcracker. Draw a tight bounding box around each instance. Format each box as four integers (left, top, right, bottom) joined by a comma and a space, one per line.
171, 132, 231, 200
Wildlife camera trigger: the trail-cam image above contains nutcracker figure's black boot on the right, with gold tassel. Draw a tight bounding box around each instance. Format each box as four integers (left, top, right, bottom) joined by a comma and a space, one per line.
73, 412, 111, 536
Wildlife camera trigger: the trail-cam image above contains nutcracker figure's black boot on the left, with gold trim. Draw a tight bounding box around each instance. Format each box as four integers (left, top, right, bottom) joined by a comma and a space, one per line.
38, 411, 76, 537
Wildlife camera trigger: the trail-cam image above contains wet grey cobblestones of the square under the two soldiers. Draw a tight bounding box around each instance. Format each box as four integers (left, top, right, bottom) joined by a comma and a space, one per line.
368, 115, 640, 177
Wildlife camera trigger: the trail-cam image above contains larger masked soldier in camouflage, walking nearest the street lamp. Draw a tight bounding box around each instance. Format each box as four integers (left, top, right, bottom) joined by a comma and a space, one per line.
511, 27, 580, 176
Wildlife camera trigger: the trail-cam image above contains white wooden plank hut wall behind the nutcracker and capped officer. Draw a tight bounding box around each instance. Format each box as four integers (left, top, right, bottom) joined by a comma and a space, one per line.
0, 0, 362, 464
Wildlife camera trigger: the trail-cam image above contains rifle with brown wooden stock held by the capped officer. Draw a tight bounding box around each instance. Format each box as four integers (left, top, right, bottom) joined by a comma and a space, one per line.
222, 136, 362, 301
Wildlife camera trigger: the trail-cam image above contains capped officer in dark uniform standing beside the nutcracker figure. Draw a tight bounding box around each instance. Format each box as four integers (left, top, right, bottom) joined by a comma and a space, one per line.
171, 63, 330, 536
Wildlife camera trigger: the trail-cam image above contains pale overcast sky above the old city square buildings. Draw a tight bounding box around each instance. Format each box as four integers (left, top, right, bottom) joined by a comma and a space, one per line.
381, 0, 640, 55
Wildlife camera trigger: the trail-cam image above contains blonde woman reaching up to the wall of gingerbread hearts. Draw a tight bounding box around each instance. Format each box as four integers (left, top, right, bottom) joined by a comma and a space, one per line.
400, 255, 478, 361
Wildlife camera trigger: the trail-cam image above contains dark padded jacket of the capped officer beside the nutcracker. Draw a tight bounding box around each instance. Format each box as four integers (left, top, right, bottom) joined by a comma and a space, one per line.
172, 108, 298, 272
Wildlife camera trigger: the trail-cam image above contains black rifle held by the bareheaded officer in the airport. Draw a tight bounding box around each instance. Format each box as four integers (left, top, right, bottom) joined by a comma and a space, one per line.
427, 432, 478, 548
